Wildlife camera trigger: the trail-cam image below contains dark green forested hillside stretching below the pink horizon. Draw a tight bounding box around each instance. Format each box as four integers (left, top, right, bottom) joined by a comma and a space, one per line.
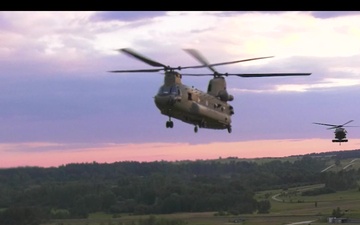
0, 150, 360, 224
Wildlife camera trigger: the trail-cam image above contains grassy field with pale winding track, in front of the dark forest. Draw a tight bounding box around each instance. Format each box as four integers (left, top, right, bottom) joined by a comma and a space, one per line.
44, 184, 360, 225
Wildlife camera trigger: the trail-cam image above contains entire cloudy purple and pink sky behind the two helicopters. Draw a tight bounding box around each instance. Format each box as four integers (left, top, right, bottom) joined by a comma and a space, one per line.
0, 11, 360, 168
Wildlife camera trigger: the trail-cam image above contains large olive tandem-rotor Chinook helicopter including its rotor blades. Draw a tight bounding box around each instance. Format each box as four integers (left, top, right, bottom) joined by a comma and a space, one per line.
109, 48, 311, 133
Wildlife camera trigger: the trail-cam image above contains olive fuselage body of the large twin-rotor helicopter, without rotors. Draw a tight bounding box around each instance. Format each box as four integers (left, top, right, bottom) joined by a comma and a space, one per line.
154, 72, 234, 132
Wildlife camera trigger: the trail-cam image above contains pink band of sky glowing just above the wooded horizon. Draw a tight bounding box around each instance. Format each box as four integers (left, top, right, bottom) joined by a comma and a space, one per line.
0, 139, 360, 168
